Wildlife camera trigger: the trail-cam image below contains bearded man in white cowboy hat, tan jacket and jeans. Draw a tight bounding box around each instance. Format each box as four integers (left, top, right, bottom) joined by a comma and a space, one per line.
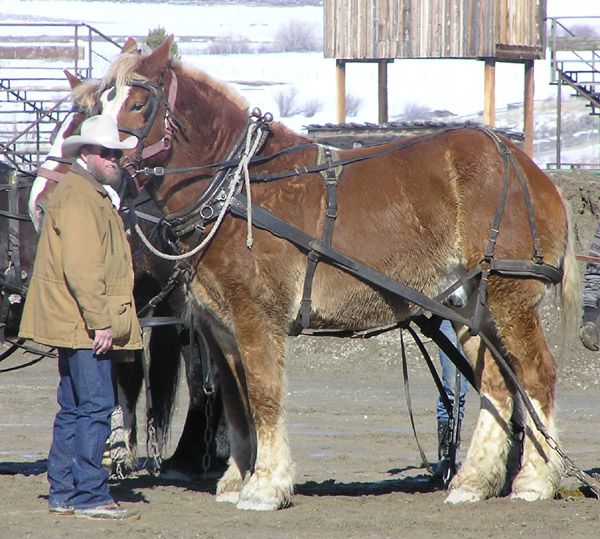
20, 115, 142, 520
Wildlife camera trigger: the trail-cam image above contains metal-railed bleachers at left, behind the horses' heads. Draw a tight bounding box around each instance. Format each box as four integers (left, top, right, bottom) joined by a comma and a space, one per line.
0, 23, 120, 174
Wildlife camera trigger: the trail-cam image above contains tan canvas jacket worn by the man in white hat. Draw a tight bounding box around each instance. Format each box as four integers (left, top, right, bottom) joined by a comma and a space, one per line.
19, 164, 142, 350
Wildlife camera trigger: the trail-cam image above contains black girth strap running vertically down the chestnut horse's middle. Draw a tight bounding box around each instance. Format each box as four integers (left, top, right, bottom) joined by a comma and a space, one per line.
294, 145, 343, 333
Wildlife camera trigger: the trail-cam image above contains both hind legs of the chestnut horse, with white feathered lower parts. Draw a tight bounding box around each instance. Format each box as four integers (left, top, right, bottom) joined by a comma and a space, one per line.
447, 279, 563, 502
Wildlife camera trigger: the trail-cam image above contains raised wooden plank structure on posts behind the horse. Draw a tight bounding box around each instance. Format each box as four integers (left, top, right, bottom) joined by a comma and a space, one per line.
324, 0, 546, 155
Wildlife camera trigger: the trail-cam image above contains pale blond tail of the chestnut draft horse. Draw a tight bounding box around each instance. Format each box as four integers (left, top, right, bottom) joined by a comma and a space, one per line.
557, 188, 581, 356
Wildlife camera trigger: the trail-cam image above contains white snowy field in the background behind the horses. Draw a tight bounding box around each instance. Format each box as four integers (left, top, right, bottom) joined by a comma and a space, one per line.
0, 0, 600, 165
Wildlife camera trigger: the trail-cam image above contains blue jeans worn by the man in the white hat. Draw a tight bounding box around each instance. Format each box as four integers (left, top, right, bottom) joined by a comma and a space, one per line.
48, 348, 115, 509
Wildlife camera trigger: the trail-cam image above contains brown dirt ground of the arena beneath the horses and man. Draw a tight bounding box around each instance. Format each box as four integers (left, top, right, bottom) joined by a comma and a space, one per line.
0, 171, 600, 539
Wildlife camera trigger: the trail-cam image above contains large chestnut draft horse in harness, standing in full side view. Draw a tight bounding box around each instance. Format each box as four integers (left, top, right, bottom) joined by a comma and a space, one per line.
100, 36, 578, 510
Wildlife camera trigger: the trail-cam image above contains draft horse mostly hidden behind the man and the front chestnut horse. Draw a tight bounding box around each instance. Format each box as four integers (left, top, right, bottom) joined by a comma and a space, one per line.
27, 66, 227, 479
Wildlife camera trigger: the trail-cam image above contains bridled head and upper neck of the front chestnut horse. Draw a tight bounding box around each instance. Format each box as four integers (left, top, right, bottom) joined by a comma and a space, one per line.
100, 35, 247, 199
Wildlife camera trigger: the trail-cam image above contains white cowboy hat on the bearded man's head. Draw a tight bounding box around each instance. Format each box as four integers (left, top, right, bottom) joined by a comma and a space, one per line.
62, 114, 138, 157
